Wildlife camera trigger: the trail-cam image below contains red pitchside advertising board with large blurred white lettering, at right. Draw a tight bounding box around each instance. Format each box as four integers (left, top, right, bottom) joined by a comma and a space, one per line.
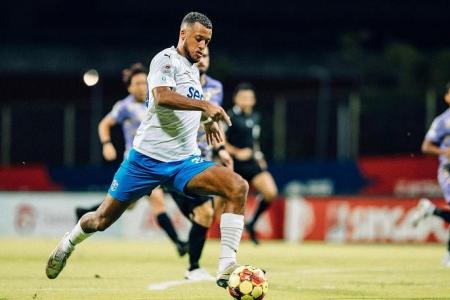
210, 196, 448, 243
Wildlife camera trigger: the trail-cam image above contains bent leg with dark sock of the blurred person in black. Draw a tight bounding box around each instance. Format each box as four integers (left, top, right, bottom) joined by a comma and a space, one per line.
245, 171, 278, 244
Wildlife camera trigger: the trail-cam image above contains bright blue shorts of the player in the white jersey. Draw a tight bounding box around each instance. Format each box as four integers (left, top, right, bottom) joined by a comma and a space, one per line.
108, 149, 215, 202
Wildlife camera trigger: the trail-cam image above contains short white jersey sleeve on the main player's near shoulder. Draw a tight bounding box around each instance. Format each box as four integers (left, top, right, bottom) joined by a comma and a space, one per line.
148, 53, 176, 91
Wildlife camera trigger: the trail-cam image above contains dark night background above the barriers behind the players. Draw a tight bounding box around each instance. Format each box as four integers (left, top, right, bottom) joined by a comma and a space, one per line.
0, 0, 450, 165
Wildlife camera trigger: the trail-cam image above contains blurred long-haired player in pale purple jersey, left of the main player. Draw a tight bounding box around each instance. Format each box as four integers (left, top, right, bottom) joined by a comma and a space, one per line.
76, 63, 188, 256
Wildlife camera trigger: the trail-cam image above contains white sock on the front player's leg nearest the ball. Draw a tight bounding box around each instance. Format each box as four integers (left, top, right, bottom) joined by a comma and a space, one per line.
219, 213, 244, 272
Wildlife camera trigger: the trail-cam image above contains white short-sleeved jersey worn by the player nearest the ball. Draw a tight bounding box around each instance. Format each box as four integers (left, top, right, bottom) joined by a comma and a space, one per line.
133, 47, 203, 162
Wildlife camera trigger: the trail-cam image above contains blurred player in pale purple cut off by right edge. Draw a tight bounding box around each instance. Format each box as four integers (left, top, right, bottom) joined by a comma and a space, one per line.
413, 83, 450, 267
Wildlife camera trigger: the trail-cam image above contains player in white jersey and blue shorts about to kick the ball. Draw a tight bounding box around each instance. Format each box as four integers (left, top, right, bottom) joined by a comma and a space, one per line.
46, 12, 248, 288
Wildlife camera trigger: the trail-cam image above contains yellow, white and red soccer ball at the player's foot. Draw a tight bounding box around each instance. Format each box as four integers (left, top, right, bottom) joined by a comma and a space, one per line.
228, 266, 269, 300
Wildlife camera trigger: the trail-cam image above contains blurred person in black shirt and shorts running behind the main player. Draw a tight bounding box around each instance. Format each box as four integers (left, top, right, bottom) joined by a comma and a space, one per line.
226, 83, 278, 244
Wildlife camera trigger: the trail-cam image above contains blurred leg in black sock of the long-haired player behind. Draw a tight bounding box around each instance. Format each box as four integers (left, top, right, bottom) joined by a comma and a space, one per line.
148, 188, 188, 256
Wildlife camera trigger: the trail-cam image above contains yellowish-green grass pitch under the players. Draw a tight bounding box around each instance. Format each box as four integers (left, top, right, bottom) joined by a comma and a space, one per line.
0, 239, 450, 300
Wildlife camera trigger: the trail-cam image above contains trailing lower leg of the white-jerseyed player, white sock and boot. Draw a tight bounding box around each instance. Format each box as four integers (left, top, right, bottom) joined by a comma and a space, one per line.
45, 194, 129, 279
